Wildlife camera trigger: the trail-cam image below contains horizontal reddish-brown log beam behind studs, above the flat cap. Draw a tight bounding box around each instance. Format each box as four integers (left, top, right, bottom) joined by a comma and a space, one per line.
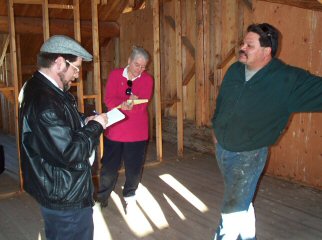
0, 16, 120, 38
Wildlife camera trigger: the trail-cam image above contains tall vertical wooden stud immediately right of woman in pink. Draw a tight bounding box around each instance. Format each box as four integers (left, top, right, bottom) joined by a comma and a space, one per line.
152, 0, 162, 161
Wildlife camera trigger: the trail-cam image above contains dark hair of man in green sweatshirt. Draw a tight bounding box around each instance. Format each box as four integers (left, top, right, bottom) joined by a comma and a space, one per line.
247, 23, 279, 57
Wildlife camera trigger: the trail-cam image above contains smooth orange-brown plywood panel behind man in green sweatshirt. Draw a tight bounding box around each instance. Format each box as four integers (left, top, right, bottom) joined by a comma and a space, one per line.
254, 1, 322, 188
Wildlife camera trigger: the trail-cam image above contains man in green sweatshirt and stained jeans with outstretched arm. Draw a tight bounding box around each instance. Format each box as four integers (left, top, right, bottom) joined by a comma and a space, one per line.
212, 23, 322, 240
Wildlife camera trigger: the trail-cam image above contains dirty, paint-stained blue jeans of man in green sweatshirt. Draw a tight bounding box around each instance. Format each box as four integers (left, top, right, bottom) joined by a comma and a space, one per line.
214, 144, 268, 240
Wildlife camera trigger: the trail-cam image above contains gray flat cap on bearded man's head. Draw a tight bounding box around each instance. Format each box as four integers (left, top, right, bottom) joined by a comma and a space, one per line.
40, 35, 93, 61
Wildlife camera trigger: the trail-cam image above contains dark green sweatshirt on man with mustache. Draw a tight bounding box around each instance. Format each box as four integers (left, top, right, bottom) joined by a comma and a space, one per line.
212, 58, 322, 152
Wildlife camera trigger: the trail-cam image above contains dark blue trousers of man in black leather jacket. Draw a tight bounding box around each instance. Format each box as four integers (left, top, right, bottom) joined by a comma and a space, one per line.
40, 207, 94, 240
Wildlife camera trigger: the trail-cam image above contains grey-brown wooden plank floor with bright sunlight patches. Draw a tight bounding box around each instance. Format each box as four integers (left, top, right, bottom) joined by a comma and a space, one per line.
0, 134, 322, 240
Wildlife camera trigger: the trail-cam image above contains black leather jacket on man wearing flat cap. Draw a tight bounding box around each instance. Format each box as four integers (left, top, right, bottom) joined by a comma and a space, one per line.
19, 72, 103, 210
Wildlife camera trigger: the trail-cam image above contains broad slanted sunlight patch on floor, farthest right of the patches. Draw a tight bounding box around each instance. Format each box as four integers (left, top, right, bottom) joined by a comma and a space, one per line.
159, 174, 209, 212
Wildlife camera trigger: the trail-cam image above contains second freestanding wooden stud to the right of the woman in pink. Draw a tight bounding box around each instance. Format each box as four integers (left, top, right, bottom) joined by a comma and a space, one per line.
175, 0, 183, 156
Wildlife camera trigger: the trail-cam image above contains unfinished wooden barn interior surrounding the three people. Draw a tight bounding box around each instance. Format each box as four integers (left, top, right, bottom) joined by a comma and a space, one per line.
0, 0, 322, 239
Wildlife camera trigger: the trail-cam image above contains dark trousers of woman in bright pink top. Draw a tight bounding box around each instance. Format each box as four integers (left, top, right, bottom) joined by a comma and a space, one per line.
97, 137, 147, 201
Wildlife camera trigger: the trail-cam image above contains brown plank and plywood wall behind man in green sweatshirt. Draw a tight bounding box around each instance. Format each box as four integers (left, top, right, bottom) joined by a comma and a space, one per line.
149, 0, 322, 188
